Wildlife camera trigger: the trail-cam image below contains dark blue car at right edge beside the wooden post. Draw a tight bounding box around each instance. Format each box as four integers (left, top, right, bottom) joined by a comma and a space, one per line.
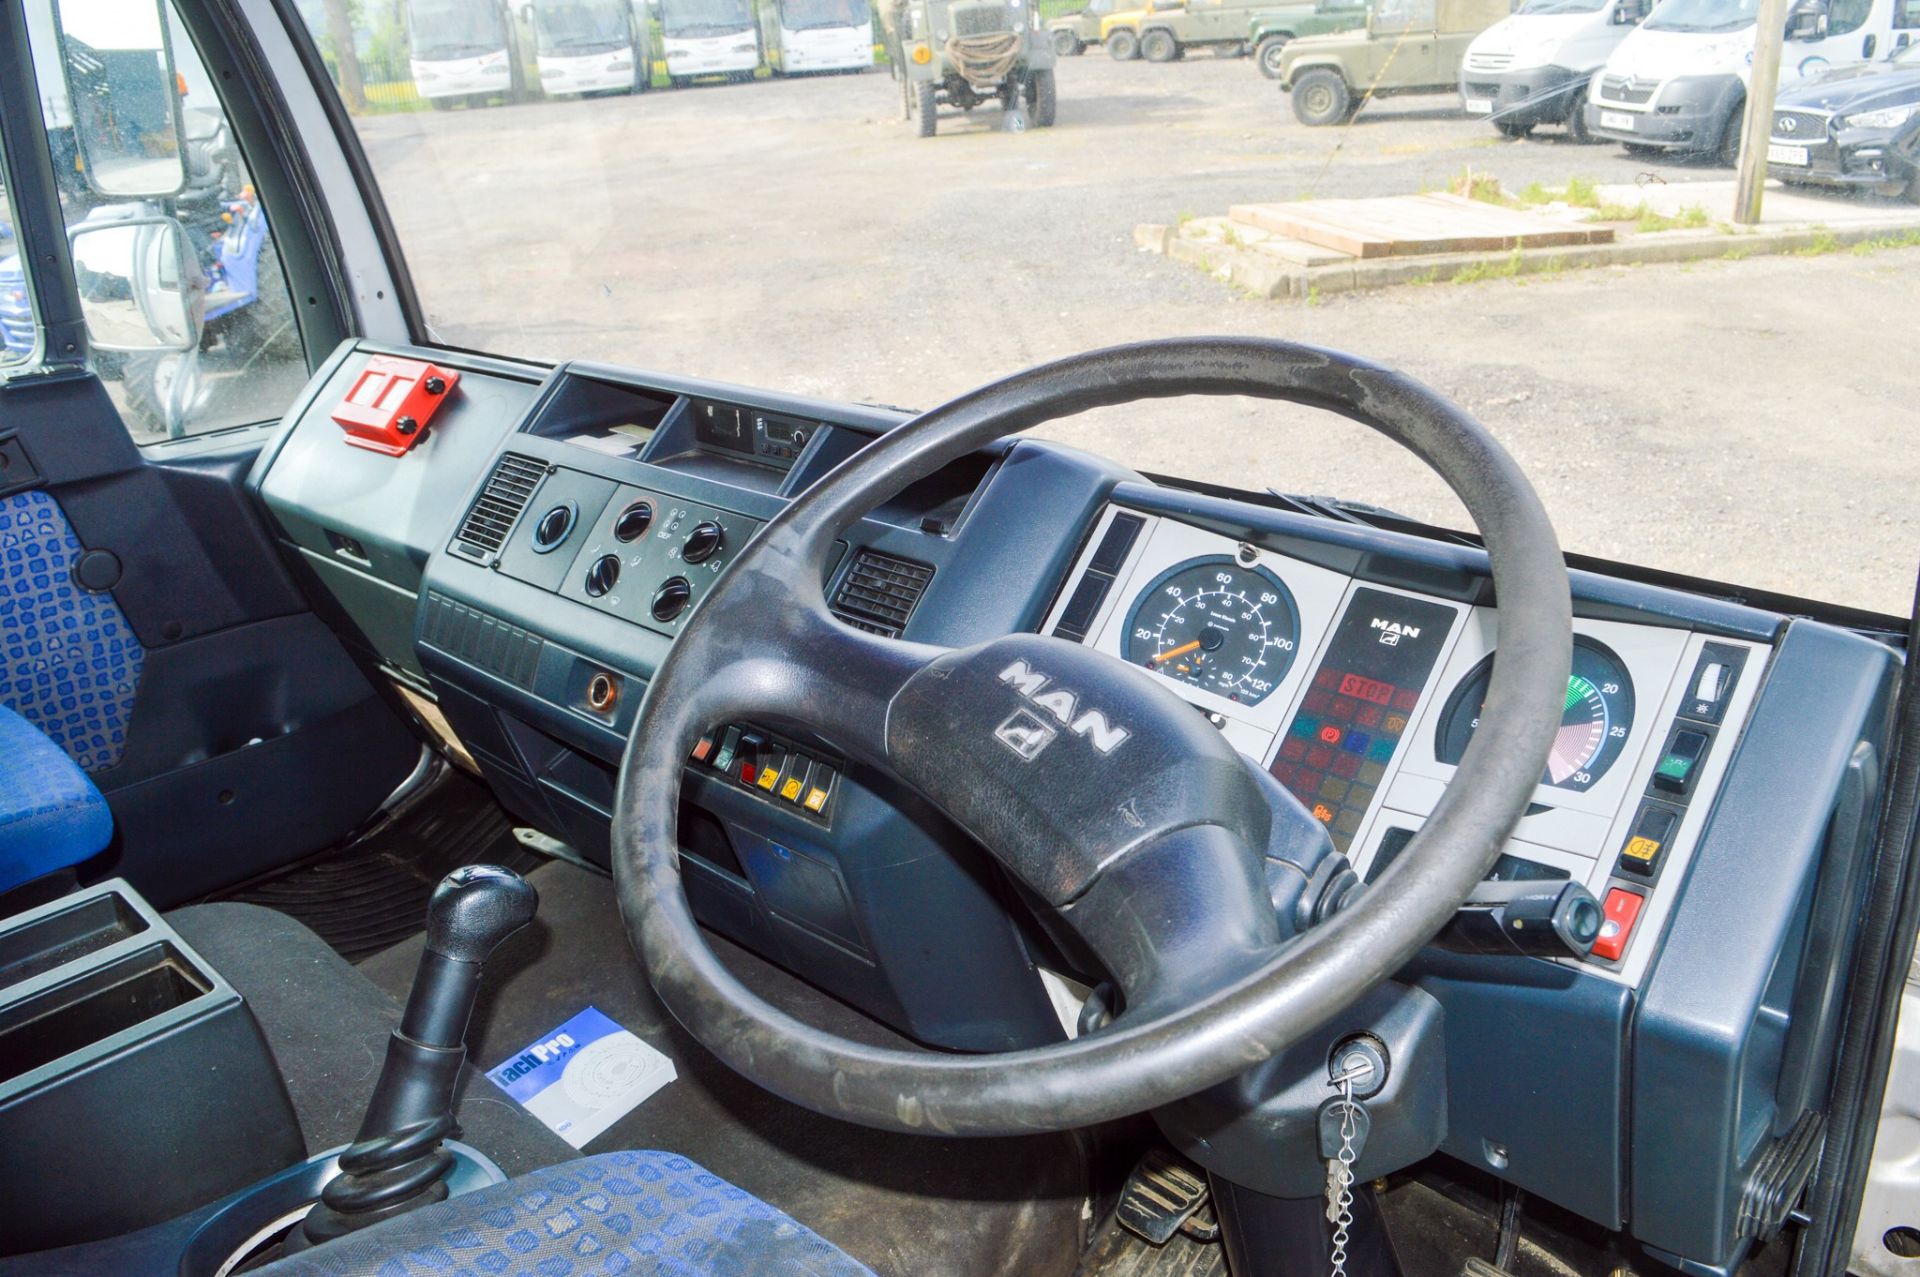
1766, 42, 1920, 204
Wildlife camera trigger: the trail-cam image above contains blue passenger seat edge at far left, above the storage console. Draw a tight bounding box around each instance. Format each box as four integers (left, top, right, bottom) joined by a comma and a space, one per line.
0, 705, 113, 891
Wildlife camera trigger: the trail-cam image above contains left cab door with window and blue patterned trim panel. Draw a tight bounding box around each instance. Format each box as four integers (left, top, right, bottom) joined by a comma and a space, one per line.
0, 0, 420, 906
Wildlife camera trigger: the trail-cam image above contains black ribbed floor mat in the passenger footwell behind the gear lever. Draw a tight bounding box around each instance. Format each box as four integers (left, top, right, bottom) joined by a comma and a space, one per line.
221, 772, 547, 962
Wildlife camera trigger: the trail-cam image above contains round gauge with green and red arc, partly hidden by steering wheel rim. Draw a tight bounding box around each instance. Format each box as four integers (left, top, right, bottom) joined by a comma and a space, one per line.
1434, 634, 1634, 793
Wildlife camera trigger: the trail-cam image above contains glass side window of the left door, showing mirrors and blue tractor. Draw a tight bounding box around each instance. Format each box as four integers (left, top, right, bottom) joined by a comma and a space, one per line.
23, 0, 309, 446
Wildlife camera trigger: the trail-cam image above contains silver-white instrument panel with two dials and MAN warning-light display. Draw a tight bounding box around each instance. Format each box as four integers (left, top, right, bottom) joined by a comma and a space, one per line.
1043, 505, 1766, 983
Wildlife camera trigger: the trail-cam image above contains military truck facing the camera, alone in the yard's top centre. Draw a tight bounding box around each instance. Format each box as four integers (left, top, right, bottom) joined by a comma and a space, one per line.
887, 0, 1056, 138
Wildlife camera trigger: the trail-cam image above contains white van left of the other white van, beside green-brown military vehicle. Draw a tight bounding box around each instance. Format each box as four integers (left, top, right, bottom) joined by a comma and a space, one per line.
1459, 0, 1653, 142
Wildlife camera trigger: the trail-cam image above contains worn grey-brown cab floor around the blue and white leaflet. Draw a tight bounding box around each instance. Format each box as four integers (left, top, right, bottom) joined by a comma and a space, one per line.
361, 862, 1085, 1277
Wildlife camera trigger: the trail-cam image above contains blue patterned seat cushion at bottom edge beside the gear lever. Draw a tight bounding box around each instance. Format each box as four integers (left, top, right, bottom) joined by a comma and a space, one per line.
255, 1152, 874, 1277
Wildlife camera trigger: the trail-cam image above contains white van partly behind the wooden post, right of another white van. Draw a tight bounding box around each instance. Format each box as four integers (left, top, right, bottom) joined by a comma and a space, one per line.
1586, 0, 1901, 163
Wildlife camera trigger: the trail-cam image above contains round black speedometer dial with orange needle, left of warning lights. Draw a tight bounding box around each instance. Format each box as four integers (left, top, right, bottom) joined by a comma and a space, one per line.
1127, 559, 1300, 705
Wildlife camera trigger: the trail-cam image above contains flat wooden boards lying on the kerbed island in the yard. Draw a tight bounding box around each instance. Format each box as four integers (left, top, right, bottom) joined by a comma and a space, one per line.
1227, 194, 1613, 257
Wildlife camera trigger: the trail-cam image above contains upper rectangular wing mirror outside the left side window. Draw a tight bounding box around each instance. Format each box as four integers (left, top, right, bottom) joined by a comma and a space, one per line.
54, 0, 186, 200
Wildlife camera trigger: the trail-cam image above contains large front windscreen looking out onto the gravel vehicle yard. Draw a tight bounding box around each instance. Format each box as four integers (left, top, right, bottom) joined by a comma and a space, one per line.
300, 0, 1920, 614
